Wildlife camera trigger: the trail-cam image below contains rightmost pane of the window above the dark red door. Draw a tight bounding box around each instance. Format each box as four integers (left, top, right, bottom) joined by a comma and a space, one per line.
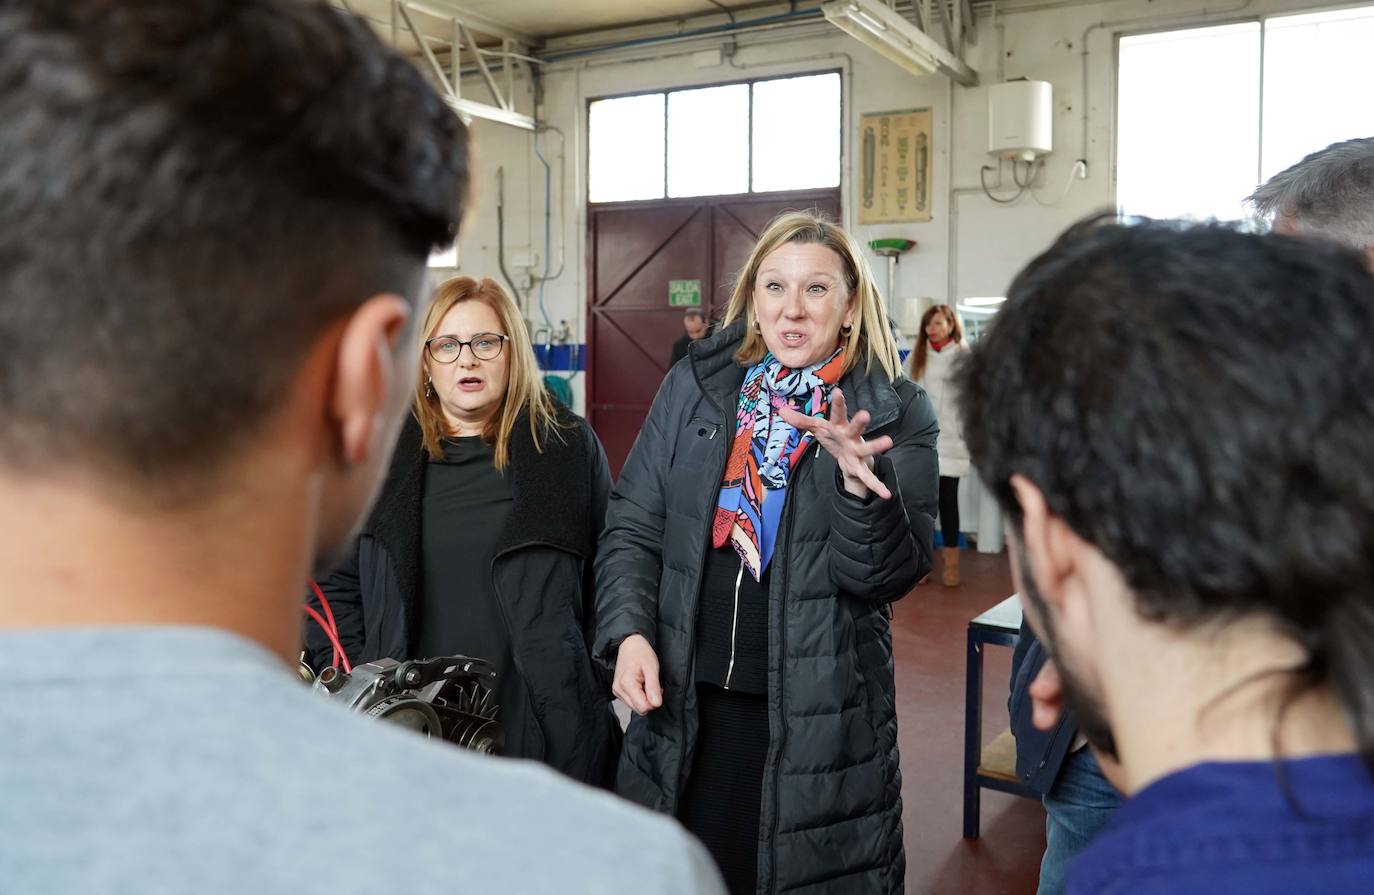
753, 73, 844, 192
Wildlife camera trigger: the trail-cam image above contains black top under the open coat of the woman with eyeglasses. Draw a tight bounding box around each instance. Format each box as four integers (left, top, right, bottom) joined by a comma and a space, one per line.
415, 436, 525, 745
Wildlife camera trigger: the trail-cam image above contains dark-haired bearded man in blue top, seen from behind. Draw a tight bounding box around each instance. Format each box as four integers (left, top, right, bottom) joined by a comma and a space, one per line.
959, 221, 1374, 895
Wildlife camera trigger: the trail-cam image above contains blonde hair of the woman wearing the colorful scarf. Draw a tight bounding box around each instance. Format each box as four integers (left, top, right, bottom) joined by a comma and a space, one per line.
723, 212, 901, 382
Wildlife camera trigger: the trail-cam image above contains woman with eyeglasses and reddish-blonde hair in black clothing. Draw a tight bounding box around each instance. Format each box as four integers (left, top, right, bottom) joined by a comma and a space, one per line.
308, 276, 620, 785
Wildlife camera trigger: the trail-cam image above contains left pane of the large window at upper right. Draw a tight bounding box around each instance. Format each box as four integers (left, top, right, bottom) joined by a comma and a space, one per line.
1117, 22, 1260, 220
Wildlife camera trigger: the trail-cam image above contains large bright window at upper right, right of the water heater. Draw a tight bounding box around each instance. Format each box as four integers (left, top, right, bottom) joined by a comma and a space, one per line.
1117, 5, 1374, 219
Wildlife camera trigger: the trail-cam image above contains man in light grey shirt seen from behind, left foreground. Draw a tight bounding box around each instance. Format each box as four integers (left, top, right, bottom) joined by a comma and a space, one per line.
0, 0, 719, 895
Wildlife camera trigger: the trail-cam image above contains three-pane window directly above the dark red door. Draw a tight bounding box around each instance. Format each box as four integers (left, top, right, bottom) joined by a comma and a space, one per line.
587, 71, 844, 202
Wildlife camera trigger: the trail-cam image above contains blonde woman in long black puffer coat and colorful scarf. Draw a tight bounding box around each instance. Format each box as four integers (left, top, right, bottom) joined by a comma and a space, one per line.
594, 212, 938, 894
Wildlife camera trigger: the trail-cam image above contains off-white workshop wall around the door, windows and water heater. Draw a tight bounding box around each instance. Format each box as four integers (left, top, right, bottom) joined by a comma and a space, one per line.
442, 0, 1329, 410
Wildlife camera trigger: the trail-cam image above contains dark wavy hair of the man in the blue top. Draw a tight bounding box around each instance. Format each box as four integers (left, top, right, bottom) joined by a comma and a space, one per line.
959, 219, 1374, 767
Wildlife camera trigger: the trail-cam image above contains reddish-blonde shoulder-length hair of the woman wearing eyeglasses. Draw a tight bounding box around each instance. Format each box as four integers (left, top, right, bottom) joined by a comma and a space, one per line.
414, 276, 562, 470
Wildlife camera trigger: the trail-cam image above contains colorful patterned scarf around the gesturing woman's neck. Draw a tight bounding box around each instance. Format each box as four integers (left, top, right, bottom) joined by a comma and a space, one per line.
710, 348, 845, 582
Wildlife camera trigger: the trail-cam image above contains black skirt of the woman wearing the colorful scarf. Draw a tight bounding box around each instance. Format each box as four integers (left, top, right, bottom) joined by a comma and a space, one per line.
677, 683, 771, 895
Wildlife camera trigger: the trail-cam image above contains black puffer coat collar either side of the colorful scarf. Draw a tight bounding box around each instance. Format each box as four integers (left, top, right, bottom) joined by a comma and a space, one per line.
688, 320, 901, 432
